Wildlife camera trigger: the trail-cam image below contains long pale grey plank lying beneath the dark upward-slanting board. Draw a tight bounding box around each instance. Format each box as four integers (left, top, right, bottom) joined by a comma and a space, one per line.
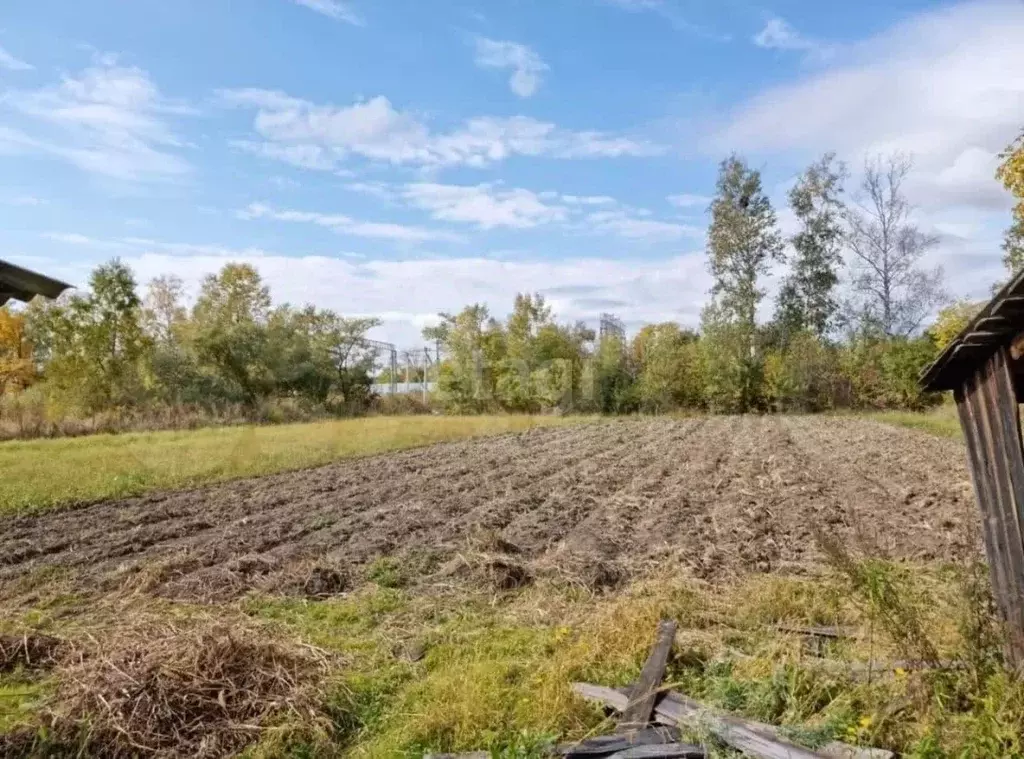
572, 683, 822, 759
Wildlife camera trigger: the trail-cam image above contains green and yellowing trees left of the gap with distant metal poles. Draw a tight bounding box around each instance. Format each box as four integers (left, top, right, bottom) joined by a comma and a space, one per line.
0, 259, 379, 430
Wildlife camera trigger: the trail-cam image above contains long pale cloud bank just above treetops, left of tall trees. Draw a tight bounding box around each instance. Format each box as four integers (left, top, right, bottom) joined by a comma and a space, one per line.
24, 241, 710, 347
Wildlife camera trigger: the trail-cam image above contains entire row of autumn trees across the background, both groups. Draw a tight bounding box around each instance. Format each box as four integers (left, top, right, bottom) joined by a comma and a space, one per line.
0, 135, 1024, 430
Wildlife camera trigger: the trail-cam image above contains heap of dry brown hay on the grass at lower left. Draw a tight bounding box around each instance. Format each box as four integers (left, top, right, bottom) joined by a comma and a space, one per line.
52, 623, 332, 758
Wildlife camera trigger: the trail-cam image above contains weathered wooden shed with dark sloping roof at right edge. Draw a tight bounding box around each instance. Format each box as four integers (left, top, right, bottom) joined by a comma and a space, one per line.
921, 272, 1024, 667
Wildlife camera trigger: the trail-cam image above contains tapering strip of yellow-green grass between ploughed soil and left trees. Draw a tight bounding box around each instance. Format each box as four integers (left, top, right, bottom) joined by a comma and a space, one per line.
0, 416, 580, 513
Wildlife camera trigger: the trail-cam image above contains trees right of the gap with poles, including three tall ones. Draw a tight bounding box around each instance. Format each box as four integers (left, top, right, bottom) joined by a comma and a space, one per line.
424, 152, 1007, 413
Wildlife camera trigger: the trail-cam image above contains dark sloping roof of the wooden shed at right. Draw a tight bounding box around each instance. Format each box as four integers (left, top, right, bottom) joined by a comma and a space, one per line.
921, 271, 1024, 394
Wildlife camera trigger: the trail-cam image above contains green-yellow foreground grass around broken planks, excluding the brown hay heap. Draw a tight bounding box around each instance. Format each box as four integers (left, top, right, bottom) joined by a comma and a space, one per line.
235, 563, 1011, 759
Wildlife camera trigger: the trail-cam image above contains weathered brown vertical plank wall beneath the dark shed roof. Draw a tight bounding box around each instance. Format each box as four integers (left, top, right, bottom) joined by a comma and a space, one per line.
954, 348, 1024, 667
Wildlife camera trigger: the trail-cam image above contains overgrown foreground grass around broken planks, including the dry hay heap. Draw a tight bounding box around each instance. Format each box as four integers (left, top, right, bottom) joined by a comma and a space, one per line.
0, 561, 1024, 759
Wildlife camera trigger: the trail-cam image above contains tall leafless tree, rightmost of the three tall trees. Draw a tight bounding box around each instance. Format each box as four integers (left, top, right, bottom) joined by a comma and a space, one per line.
846, 154, 947, 337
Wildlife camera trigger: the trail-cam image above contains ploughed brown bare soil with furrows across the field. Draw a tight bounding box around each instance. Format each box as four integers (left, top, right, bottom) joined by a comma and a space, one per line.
0, 417, 980, 602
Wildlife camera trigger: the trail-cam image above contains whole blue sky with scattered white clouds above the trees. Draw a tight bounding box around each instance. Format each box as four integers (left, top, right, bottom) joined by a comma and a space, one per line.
0, 0, 1024, 347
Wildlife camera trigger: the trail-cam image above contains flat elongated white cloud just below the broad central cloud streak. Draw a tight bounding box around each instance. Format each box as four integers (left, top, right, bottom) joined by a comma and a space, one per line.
402, 182, 568, 229
